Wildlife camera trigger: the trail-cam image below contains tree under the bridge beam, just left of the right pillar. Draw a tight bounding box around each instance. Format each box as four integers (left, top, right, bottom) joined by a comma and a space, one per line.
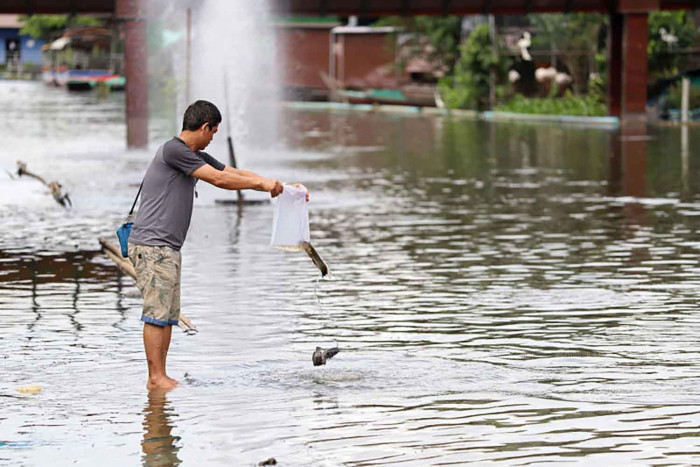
528, 13, 606, 94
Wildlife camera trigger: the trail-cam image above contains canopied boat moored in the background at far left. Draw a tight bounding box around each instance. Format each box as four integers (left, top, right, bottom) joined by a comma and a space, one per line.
42, 27, 126, 91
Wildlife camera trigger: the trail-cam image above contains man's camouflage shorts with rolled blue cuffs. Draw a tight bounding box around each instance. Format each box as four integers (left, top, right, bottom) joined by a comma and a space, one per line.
129, 243, 182, 326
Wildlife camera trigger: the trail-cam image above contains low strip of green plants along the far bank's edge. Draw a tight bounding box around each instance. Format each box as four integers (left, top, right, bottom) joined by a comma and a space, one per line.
497, 92, 607, 117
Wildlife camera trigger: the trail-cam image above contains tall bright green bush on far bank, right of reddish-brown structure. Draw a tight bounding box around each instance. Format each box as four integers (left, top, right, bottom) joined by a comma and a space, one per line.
438, 24, 505, 109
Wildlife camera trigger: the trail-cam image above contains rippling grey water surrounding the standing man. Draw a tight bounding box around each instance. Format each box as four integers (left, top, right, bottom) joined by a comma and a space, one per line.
0, 82, 700, 466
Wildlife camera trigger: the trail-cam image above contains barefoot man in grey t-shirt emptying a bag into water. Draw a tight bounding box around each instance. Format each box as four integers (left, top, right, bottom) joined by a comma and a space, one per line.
129, 101, 283, 389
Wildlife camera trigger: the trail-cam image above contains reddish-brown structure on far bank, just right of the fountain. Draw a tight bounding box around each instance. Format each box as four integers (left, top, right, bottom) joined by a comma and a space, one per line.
276, 18, 444, 106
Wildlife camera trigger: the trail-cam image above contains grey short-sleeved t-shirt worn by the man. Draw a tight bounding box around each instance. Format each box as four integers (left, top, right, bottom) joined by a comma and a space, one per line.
129, 137, 226, 250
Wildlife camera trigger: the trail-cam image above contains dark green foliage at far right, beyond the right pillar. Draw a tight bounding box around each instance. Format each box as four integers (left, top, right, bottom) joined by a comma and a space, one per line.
647, 11, 695, 79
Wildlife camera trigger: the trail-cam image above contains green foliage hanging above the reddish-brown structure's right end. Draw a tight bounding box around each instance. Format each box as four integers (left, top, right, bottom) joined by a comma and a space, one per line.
374, 16, 462, 73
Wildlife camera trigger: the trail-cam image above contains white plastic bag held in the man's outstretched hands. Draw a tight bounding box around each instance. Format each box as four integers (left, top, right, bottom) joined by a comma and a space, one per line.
270, 185, 311, 251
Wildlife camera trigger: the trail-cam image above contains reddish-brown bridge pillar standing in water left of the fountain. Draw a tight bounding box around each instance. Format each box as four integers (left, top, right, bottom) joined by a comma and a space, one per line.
115, 0, 148, 148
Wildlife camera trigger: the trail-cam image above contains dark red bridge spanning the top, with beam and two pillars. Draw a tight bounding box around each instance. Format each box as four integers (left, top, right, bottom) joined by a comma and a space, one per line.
0, 0, 700, 147
